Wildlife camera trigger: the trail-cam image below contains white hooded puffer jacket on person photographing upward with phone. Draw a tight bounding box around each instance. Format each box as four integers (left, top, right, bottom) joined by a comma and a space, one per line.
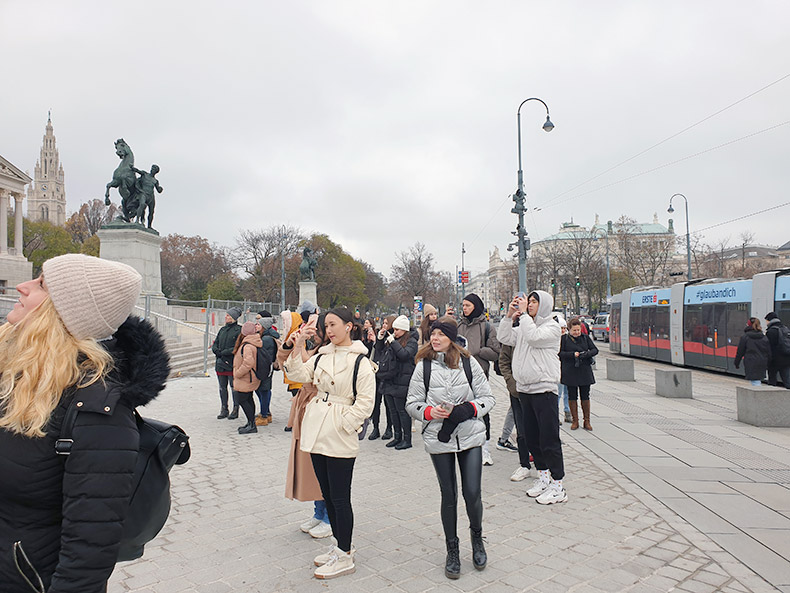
497, 290, 562, 393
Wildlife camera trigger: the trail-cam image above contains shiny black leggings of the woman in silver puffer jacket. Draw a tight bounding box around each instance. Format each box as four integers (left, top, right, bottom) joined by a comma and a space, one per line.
431, 447, 483, 539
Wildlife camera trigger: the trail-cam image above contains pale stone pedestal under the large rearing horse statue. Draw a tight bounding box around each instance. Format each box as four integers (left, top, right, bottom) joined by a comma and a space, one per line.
97, 223, 164, 298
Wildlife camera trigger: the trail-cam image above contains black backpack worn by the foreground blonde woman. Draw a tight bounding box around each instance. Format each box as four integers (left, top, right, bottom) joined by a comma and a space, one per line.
55, 401, 190, 562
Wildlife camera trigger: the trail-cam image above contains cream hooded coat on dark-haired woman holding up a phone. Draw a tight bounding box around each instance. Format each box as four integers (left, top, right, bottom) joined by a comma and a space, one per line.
284, 340, 376, 458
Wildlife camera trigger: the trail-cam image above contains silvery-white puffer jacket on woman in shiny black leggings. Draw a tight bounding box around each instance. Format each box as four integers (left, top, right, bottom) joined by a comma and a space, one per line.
406, 352, 496, 455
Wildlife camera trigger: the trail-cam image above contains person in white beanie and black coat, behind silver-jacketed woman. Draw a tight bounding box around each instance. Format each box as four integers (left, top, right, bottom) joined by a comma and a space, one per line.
376, 315, 417, 451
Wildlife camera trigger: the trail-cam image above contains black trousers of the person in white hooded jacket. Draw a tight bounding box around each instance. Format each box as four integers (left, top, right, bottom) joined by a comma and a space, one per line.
518, 391, 565, 480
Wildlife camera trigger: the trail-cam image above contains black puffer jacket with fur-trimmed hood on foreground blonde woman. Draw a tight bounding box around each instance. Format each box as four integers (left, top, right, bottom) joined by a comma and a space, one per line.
0, 317, 170, 593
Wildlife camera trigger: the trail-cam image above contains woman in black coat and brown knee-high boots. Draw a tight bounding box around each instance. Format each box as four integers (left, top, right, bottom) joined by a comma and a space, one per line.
560, 317, 598, 430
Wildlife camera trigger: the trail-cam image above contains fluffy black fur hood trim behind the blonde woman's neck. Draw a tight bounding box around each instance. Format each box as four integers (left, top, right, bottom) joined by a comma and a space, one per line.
102, 317, 170, 408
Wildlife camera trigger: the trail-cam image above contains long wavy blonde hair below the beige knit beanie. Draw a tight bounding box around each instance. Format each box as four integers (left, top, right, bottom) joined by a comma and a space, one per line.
0, 298, 113, 437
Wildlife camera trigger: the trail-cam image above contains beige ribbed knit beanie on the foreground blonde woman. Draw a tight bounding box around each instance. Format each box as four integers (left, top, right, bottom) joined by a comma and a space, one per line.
43, 253, 143, 340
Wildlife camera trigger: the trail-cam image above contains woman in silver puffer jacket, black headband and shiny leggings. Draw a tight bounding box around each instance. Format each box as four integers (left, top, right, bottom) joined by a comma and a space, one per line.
406, 316, 496, 579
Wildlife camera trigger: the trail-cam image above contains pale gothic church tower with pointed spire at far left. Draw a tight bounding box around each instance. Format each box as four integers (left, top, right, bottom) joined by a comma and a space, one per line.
27, 114, 66, 226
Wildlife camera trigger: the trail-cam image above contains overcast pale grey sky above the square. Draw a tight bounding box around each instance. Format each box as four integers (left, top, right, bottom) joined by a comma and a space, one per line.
0, 0, 790, 275
